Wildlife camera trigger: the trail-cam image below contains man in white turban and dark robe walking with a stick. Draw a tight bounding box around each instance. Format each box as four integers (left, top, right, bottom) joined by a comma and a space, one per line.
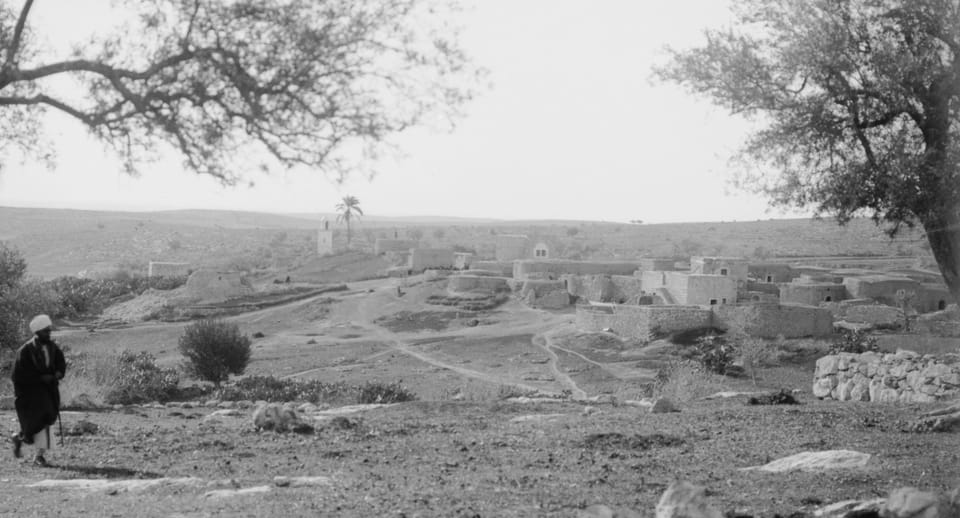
12, 315, 67, 466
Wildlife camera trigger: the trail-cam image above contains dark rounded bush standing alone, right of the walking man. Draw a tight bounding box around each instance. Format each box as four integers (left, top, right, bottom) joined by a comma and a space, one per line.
179, 319, 250, 387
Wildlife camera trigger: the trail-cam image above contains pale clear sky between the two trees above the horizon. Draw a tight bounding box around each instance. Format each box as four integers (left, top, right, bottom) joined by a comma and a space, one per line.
0, 0, 801, 223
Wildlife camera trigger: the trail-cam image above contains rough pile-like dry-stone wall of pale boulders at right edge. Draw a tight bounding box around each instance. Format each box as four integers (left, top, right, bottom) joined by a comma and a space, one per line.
813, 351, 960, 403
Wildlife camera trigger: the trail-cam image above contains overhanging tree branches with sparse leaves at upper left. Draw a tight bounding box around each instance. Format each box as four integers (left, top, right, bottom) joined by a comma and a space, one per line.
0, 0, 476, 183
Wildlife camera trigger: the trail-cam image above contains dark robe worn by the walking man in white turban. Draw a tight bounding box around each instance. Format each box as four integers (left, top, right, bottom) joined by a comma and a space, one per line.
12, 336, 67, 444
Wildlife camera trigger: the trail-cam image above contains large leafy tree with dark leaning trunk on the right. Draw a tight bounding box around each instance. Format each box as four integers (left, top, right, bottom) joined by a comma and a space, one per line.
657, 0, 960, 297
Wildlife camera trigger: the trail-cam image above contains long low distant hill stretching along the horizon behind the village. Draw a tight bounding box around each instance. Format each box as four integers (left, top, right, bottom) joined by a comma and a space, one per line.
0, 207, 932, 277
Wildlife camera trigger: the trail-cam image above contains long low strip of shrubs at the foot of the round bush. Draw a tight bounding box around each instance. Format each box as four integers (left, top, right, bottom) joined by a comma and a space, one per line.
220, 376, 355, 404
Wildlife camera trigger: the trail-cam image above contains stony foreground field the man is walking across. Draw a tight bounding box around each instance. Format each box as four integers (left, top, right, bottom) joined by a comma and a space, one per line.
0, 397, 960, 516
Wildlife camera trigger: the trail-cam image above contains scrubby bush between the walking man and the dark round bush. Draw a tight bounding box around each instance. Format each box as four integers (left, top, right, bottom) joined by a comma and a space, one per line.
104, 351, 180, 405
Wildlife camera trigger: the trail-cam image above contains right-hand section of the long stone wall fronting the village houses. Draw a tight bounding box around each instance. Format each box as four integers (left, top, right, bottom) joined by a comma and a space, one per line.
712, 304, 833, 338
